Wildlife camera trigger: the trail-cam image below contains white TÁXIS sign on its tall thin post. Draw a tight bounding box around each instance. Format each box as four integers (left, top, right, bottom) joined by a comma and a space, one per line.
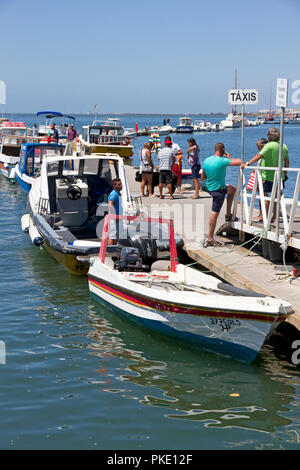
228, 89, 258, 241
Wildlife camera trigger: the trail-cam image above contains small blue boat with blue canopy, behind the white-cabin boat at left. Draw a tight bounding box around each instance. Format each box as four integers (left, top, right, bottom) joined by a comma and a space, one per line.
14, 142, 65, 192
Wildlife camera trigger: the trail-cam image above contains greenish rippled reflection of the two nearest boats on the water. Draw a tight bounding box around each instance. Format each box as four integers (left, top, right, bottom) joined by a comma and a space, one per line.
18, 235, 300, 445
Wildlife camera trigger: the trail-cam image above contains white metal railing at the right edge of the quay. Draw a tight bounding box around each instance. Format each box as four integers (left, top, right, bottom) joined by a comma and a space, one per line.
232, 166, 300, 248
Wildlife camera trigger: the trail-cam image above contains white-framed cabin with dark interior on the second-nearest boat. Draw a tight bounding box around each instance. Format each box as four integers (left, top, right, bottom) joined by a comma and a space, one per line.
39, 154, 130, 238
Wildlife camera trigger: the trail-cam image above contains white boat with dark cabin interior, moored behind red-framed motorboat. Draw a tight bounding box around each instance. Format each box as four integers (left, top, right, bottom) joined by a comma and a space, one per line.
22, 154, 137, 275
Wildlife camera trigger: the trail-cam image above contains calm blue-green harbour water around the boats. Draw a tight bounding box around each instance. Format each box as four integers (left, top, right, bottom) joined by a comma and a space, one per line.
0, 116, 300, 450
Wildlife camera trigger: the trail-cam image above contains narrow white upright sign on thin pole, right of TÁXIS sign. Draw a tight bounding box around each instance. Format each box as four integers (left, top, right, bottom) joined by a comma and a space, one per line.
276, 78, 288, 241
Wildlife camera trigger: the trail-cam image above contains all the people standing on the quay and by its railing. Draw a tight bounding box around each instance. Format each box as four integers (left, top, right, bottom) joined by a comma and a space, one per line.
141, 127, 289, 247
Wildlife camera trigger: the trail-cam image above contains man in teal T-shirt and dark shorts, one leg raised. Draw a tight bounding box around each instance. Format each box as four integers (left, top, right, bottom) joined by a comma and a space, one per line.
201, 142, 242, 247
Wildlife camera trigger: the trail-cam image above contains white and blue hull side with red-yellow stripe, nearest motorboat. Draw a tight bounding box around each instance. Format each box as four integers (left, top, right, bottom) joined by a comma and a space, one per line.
88, 273, 278, 363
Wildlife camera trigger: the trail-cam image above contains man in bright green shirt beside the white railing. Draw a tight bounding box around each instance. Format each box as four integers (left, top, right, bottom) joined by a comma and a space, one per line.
242, 127, 290, 222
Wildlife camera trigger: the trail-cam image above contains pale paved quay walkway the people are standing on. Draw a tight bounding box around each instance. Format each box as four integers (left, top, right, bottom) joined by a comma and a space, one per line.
126, 166, 300, 331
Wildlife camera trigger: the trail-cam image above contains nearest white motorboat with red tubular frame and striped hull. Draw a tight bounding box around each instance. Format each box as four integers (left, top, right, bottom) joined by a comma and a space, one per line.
88, 214, 292, 362
